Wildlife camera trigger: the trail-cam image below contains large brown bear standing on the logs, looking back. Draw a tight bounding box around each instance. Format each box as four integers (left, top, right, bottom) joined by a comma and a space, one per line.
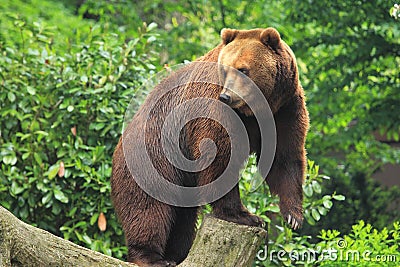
111, 28, 308, 266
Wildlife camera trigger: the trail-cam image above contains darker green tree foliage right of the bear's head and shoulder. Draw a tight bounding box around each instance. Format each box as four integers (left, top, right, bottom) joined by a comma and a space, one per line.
287, 1, 400, 234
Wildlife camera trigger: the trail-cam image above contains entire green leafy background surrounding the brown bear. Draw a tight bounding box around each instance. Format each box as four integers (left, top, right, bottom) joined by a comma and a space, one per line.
0, 0, 400, 266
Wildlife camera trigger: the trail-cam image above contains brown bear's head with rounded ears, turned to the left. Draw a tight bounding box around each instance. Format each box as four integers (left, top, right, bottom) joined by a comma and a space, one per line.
218, 28, 300, 116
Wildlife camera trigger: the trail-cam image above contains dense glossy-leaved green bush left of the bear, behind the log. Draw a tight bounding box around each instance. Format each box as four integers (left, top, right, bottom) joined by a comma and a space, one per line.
0, 5, 156, 258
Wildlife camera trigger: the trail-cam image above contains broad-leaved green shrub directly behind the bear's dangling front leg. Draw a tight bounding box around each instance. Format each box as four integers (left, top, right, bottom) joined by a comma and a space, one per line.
239, 160, 345, 266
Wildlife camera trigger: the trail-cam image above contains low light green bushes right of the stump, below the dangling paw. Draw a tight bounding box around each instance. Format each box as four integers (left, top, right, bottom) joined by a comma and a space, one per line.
240, 158, 400, 266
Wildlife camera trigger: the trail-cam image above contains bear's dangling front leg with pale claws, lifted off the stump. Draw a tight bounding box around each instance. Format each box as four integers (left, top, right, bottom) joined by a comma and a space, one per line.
267, 95, 308, 229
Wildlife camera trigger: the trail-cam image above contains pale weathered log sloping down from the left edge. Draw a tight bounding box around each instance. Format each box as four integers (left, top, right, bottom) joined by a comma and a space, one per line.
0, 206, 137, 267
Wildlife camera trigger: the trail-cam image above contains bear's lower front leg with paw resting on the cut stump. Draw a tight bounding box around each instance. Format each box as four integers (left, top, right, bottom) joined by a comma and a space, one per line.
211, 185, 264, 226
